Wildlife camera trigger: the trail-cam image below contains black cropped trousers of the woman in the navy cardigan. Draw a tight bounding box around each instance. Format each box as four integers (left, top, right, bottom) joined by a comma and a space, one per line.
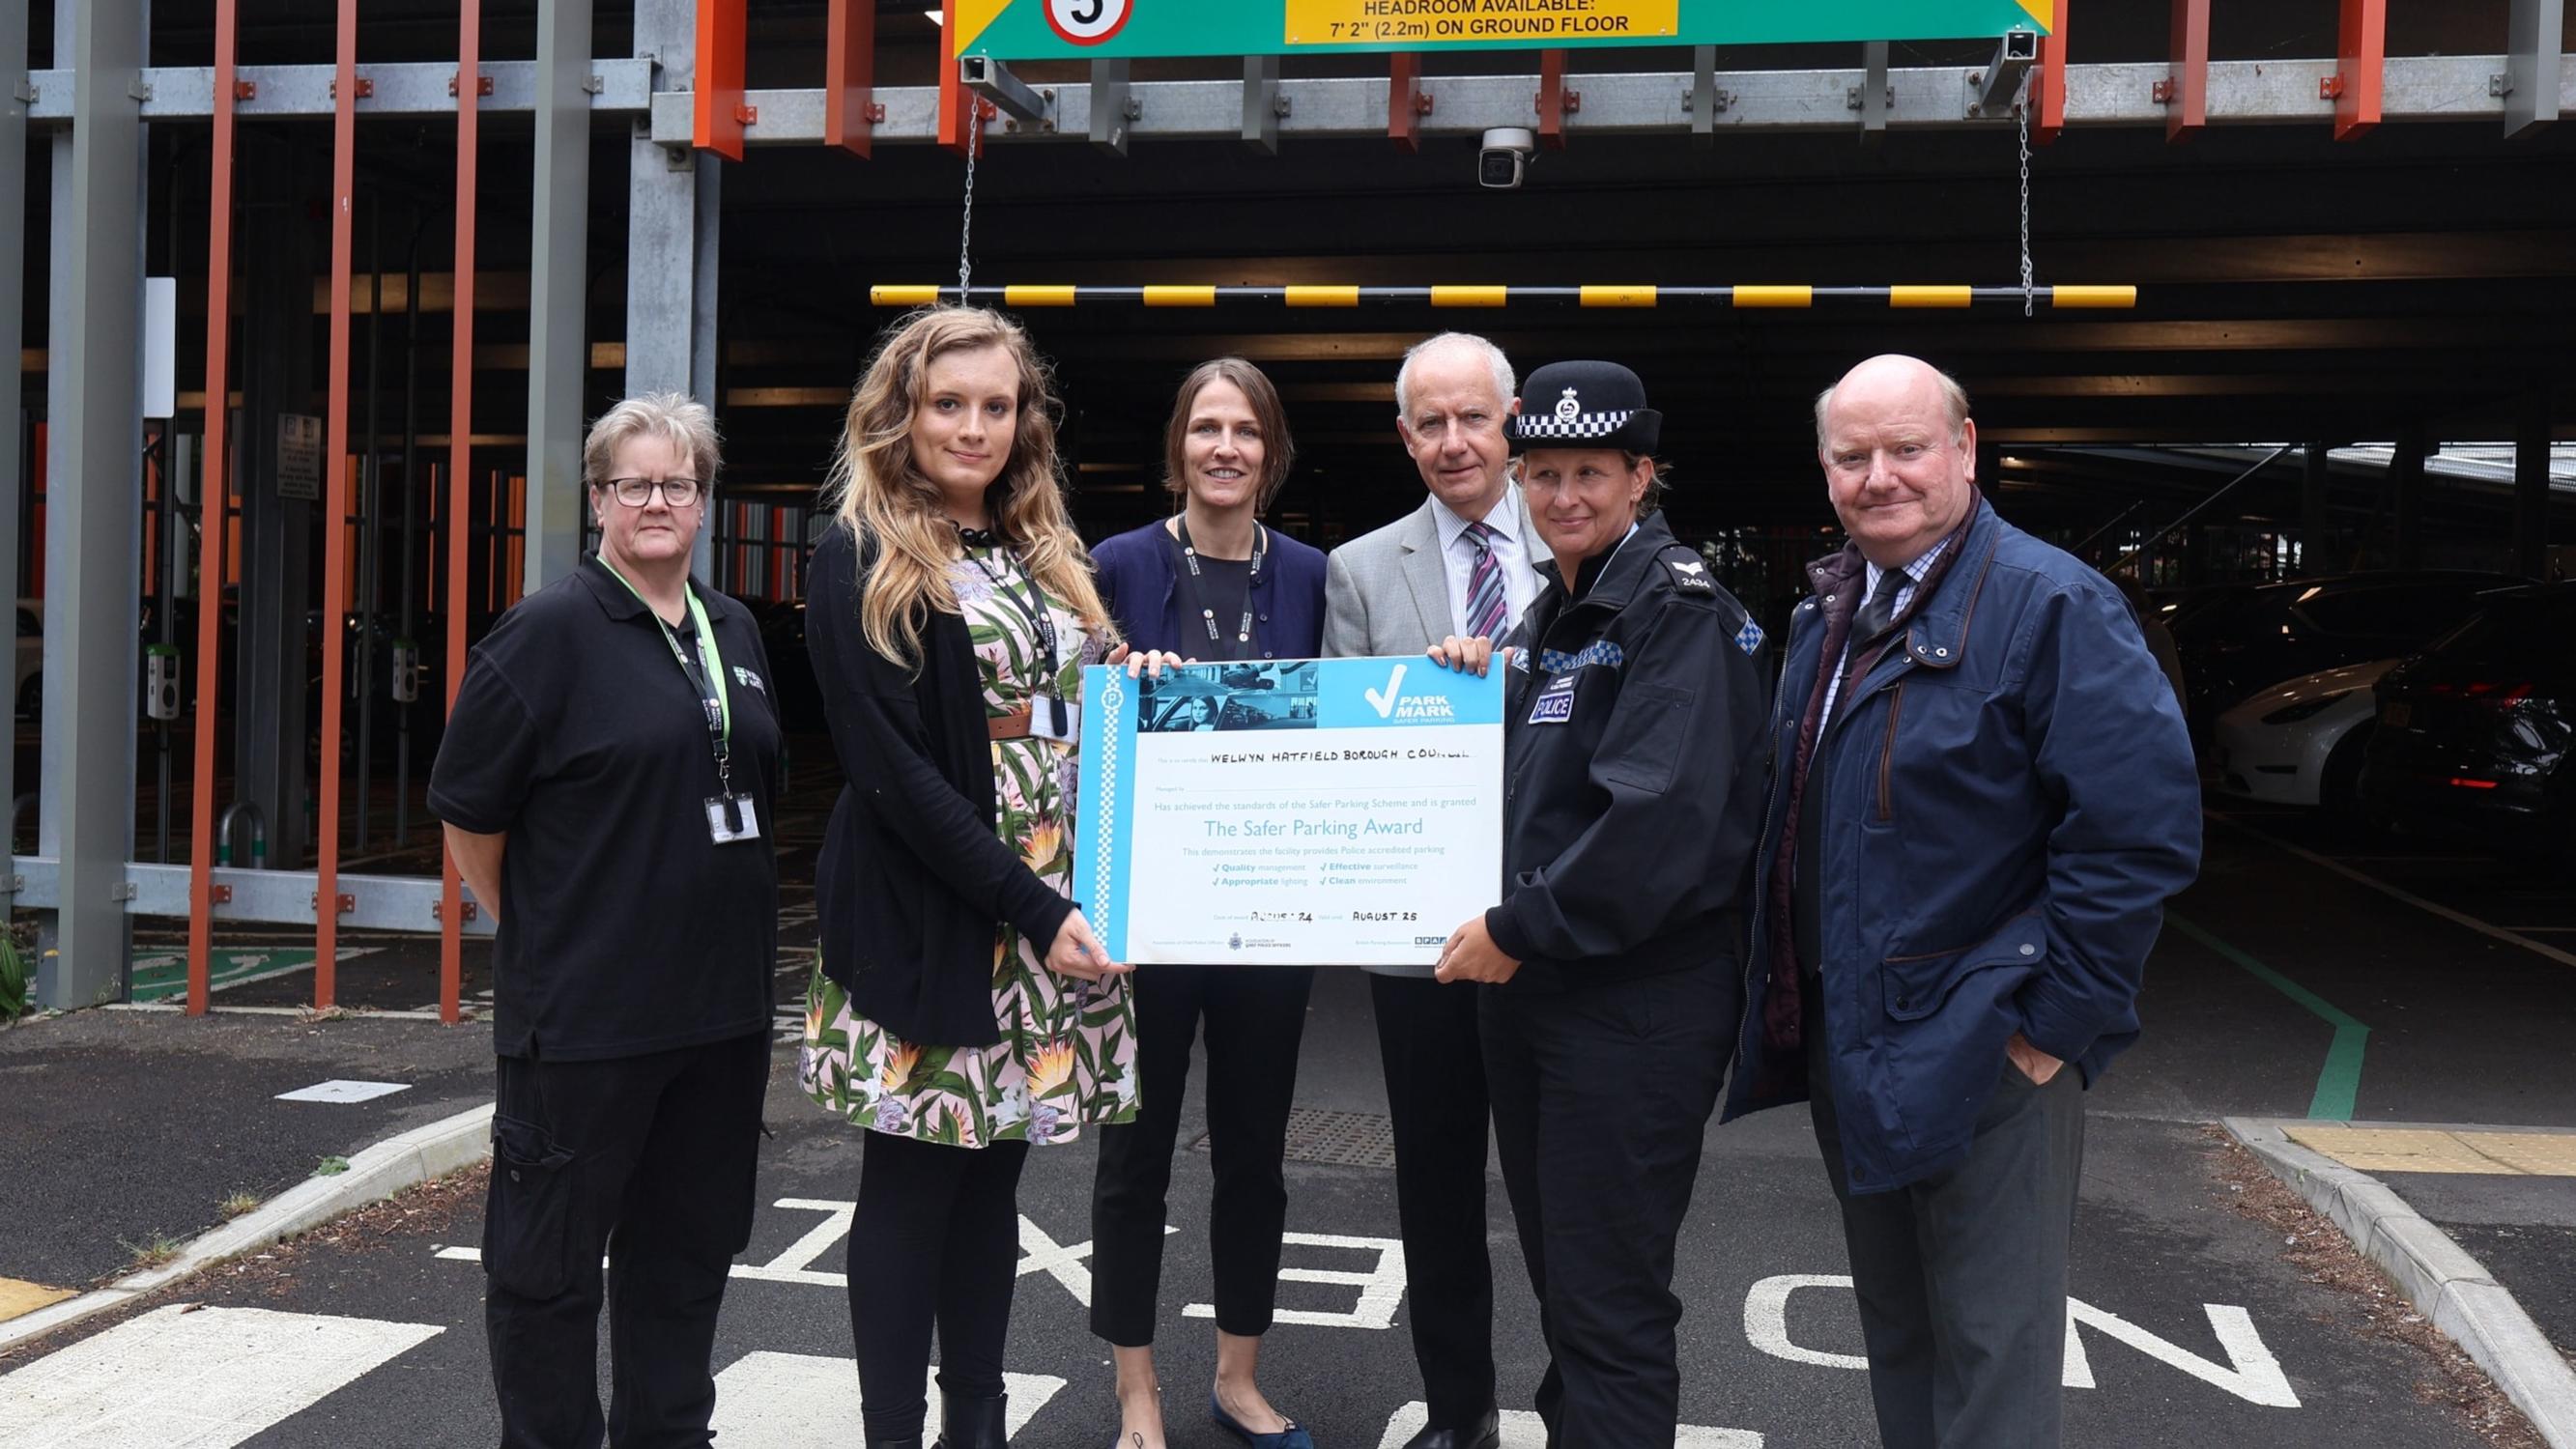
1092, 965, 1314, 1349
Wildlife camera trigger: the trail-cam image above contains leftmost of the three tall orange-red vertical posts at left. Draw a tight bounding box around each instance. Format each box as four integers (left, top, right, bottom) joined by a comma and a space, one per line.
185, 0, 240, 1016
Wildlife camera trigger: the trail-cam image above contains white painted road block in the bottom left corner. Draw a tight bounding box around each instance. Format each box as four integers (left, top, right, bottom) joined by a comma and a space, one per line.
0, 1305, 444, 1449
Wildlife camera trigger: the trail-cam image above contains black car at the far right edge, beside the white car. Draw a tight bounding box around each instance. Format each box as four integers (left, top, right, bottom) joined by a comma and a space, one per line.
2362, 584, 2576, 855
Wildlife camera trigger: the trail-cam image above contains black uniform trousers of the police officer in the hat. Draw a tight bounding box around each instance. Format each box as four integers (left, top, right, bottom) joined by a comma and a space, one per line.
1478, 960, 1741, 1449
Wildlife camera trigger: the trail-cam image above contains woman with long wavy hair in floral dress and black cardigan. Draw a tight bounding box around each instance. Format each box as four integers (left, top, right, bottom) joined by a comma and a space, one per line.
801, 309, 1136, 1449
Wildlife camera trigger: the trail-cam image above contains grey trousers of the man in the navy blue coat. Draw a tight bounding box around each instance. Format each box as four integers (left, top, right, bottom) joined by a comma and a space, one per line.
1803, 980, 2084, 1449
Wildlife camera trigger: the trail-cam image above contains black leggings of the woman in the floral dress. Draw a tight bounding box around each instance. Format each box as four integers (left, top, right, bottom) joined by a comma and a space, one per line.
850, 1132, 1028, 1444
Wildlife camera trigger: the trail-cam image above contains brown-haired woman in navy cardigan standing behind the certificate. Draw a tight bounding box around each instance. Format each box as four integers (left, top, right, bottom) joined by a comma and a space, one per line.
1092, 357, 1324, 1449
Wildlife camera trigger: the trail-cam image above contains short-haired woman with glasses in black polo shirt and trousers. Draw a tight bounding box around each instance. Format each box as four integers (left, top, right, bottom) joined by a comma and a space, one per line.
430, 394, 778, 1446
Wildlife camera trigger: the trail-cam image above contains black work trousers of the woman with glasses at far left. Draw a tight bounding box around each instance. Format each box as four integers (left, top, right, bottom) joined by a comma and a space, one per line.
484, 1032, 770, 1449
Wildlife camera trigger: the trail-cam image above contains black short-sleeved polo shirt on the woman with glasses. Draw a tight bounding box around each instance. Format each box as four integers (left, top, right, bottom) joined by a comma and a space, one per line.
430, 558, 778, 1061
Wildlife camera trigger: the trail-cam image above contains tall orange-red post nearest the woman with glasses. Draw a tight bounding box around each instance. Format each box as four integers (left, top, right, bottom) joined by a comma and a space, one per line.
438, 0, 484, 1022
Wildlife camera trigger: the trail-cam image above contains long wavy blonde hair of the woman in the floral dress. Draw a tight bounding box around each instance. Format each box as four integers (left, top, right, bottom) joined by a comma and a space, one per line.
824, 306, 1118, 667
